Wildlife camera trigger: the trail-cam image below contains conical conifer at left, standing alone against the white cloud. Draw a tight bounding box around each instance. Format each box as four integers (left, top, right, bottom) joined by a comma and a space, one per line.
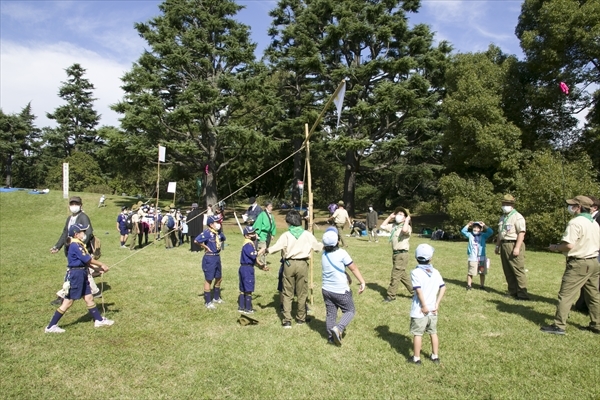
44, 63, 100, 159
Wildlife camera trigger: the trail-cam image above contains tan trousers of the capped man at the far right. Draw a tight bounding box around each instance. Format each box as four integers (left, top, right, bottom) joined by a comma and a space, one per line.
554, 258, 600, 329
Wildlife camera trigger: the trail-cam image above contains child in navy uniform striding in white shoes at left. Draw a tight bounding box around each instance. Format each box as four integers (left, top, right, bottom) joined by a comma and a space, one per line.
44, 224, 114, 333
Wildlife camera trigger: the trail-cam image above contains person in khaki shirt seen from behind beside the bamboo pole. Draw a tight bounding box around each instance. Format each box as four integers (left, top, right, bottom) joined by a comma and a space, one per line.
258, 210, 323, 328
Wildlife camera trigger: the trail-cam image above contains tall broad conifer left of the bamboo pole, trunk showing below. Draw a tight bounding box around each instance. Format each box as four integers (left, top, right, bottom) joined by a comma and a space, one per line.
114, 0, 267, 204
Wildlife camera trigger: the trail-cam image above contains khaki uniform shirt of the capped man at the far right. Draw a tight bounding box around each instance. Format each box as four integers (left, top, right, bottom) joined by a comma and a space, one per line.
561, 215, 600, 258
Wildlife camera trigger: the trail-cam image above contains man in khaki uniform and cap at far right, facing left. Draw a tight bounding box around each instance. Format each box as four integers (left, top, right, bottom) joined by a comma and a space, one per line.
541, 196, 600, 335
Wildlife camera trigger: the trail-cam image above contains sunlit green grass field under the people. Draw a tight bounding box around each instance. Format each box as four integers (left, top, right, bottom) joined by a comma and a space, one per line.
0, 192, 600, 399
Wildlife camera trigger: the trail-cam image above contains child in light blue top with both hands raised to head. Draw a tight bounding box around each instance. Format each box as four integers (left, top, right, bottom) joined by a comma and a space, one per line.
460, 221, 494, 291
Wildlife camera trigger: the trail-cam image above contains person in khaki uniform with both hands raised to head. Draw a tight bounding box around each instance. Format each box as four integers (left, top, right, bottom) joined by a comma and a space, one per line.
380, 207, 413, 303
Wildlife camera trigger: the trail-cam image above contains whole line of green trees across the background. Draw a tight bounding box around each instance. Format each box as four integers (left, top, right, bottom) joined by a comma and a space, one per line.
0, 0, 600, 243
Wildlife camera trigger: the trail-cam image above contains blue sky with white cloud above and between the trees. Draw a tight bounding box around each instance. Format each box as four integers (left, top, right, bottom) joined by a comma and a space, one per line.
0, 0, 522, 127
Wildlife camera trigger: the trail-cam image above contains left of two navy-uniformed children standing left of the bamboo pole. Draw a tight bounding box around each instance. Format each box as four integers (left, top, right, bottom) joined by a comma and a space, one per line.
194, 215, 226, 310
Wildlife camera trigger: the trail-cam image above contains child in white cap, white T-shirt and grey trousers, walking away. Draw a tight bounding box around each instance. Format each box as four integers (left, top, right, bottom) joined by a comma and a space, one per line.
321, 227, 366, 346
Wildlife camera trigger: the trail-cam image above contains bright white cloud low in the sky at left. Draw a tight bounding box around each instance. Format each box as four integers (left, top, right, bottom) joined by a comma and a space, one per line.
0, 40, 131, 127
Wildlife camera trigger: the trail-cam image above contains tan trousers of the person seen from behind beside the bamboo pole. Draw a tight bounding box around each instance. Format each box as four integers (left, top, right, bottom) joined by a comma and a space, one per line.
282, 259, 308, 322
